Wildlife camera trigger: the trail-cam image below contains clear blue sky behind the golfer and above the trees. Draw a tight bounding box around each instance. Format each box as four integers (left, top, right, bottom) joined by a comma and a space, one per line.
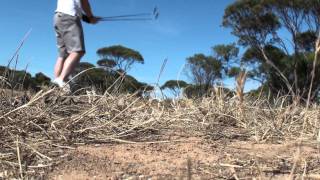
0, 0, 260, 90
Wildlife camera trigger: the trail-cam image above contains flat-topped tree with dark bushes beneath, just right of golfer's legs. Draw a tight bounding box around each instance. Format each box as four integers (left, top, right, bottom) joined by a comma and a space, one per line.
75, 45, 148, 95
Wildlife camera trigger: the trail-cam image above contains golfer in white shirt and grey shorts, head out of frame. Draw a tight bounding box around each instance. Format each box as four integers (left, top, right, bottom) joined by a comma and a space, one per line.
53, 0, 98, 91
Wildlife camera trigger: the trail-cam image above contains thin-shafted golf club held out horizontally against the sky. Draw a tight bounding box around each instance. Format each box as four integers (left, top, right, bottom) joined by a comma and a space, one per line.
82, 7, 159, 23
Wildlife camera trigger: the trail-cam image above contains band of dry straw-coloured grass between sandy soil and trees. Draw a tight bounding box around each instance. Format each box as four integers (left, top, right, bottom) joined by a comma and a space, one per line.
0, 86, 320, 179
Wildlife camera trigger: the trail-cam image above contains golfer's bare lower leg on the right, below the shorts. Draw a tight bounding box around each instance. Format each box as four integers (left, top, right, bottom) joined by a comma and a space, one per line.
58, 52, 84, 81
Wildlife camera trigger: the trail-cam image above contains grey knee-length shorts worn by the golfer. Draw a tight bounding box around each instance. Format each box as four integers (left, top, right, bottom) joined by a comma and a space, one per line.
54, 12, 85, 58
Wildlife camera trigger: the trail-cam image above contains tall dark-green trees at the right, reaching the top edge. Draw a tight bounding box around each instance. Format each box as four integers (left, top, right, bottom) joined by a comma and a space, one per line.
223, 0, 320, 101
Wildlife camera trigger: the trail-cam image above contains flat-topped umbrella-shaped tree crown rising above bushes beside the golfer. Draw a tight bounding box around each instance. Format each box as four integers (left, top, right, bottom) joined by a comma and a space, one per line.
97, 45, 144, 72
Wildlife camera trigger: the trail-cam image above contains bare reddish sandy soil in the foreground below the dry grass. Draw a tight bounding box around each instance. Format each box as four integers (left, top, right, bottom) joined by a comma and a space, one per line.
49, 136, 320, 180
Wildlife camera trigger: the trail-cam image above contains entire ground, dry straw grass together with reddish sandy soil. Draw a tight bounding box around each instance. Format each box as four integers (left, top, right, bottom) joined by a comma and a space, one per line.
0, 89, 320, 180
